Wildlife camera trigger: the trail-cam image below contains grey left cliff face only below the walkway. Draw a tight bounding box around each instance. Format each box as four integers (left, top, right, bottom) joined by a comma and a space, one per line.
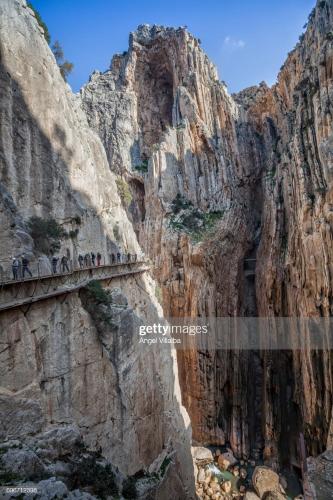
0, 278, 192, 496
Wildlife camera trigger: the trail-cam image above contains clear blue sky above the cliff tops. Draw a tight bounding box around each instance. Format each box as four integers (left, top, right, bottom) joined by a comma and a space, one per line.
32, 0, 315, 92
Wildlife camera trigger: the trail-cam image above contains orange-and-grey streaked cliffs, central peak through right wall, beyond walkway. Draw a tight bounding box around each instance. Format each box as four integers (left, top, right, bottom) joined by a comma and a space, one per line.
81, 0, 333, 468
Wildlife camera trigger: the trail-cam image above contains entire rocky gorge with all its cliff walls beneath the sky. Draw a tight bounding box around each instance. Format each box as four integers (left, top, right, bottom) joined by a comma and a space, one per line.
0, 0, 333, 500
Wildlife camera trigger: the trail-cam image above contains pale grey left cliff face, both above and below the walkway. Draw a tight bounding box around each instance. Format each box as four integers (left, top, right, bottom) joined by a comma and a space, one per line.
0, 0, 193, 498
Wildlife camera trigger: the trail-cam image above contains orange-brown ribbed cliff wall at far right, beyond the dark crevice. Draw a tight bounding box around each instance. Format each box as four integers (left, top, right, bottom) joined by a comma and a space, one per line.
238, 1, 333, 464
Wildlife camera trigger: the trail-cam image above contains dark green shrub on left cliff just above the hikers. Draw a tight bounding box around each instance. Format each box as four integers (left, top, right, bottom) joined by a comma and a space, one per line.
28, 216, 68, 255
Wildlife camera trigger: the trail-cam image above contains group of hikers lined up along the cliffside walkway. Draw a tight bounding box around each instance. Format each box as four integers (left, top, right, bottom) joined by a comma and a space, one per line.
12, 252, 138, 281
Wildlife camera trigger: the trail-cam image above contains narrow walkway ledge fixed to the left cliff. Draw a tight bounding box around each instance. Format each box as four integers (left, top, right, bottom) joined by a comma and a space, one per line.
0, 260, 150, 311
